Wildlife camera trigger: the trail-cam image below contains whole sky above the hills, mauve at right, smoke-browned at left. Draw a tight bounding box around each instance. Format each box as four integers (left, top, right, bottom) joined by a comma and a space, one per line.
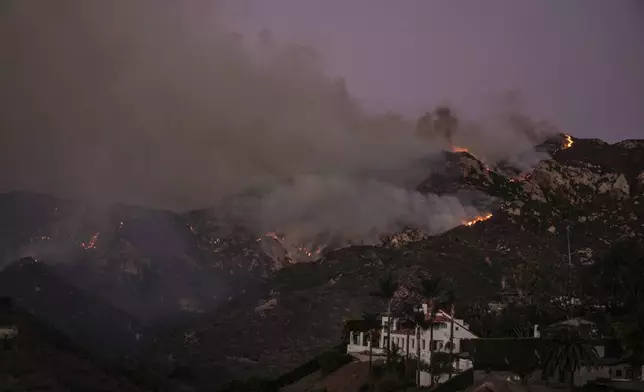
0, 0, 644, 210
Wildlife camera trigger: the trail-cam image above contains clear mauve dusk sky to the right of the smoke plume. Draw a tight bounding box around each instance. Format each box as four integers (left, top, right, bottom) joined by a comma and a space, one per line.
228, 0, 644, 141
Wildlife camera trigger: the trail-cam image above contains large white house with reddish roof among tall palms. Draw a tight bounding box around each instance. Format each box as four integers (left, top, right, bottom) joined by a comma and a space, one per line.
347, 304, 477, 386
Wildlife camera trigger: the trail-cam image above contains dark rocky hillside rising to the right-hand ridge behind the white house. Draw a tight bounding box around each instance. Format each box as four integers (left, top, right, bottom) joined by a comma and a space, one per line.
138, 138, 644, 385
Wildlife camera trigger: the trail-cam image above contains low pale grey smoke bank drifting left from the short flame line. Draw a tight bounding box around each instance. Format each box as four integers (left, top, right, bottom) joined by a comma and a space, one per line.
261, 175, 488, 242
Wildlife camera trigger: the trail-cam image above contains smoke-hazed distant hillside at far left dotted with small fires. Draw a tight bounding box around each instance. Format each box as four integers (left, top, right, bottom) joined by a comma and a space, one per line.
0, 192, 272, 323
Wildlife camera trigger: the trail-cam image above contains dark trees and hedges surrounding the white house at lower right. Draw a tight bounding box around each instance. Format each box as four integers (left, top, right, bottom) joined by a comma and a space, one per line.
216, 240, 644, 391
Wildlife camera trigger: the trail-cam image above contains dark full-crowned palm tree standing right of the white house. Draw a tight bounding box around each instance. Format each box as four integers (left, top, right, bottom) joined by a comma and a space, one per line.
543, 329, 598, 390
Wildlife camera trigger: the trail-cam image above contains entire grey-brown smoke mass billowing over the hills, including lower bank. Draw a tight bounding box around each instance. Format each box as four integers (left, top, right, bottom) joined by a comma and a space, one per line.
0, 0, 552, 258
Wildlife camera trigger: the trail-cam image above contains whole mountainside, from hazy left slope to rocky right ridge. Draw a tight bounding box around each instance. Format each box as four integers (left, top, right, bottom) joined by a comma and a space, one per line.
0, 135, 644, 387
